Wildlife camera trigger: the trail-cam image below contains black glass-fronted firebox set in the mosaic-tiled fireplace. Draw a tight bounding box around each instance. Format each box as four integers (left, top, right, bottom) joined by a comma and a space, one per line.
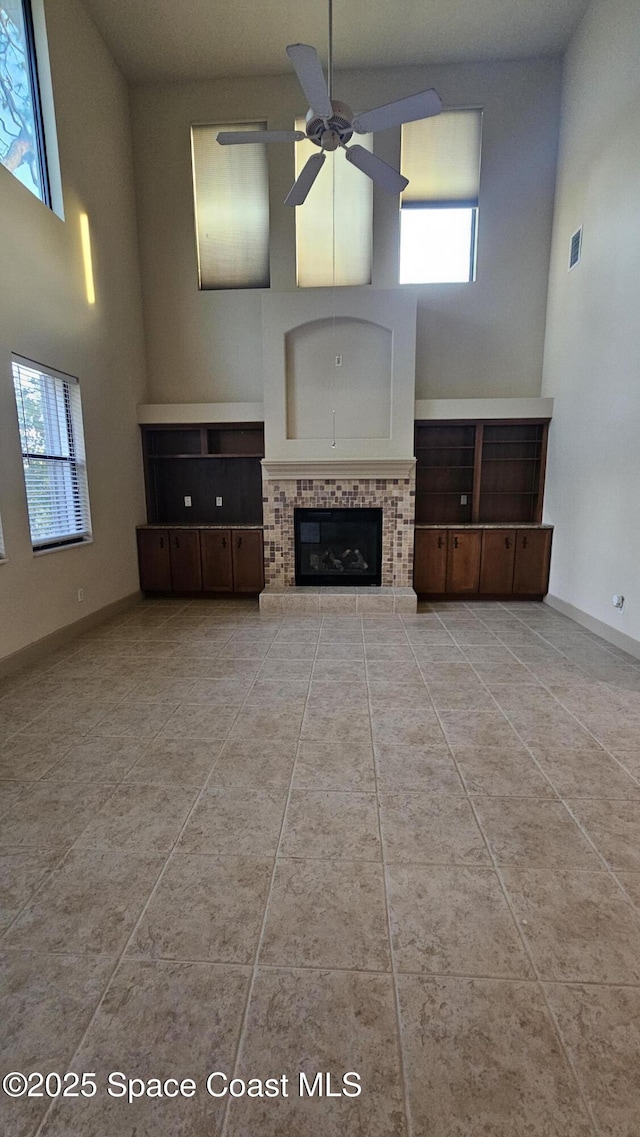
293, 509, 382, 588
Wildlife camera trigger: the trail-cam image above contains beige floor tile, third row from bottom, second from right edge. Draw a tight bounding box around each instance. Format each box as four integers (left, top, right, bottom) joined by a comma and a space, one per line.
474, 797, 602, 869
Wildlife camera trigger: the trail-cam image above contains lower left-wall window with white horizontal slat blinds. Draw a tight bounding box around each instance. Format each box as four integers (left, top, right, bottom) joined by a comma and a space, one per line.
11, 356, 91, 549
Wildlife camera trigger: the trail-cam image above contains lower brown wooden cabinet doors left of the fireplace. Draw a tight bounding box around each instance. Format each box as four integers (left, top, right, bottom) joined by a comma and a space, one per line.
138, 528, 264, 595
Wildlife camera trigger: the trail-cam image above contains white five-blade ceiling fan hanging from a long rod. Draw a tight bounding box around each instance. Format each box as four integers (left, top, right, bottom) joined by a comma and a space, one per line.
217, 0, 442, 206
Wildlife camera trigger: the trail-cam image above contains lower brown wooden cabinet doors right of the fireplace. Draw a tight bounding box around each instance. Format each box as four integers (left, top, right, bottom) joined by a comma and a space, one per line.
414, 526, 552, 598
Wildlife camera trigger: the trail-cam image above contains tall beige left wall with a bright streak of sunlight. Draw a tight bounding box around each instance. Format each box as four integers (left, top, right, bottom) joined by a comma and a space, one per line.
0, 0, 144, 657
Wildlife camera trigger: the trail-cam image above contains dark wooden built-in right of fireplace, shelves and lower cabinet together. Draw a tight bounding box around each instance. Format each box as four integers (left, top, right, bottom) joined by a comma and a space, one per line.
414, 418, 551, 598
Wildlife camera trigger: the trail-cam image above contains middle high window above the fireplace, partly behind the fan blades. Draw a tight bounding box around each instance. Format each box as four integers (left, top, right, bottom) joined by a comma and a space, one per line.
296, 118, 373, 288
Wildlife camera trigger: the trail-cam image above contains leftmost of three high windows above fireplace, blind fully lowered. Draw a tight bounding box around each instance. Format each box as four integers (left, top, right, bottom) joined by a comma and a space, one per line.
191, 123, 269, 289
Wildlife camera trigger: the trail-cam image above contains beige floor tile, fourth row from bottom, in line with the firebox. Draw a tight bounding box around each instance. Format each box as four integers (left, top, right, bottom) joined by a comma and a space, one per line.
293, 741, 375, 792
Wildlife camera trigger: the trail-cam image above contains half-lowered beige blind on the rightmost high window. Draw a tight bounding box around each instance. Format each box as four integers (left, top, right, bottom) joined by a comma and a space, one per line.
400, 109, 482, 207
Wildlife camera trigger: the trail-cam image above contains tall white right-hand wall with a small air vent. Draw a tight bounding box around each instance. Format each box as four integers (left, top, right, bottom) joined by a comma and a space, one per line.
543, 0, 640, 640
